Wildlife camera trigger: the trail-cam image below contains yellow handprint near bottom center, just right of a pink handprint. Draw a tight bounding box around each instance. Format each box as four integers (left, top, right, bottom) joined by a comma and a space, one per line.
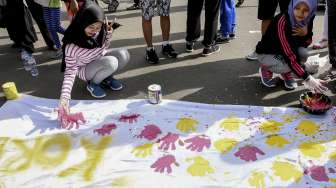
187, 156, 215, 176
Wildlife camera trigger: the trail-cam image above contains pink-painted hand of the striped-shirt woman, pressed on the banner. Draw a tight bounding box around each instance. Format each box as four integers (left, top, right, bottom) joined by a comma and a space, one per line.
57, 108, 86, 130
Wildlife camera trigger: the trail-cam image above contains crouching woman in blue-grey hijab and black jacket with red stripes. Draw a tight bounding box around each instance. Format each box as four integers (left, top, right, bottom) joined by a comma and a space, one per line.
256, 0, 327, 92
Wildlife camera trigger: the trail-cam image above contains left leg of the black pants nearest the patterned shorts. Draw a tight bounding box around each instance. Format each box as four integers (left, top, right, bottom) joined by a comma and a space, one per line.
186, 0, 204, 42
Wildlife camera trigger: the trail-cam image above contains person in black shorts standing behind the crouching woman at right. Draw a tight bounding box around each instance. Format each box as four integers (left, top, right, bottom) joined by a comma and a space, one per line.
246, 0, 290, 61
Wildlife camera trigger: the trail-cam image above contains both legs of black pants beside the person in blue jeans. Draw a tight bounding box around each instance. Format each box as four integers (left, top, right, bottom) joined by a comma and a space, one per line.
186, 0, 220, 46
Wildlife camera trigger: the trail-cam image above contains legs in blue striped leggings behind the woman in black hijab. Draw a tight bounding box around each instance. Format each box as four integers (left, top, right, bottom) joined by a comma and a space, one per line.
35, 0, 64, 59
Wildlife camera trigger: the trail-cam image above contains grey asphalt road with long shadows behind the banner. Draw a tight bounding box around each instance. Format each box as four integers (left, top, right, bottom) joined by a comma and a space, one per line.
0, 0, 335, 106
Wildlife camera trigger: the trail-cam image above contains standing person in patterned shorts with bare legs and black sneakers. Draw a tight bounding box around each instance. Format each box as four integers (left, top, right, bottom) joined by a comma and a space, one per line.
141, 0, 177, 64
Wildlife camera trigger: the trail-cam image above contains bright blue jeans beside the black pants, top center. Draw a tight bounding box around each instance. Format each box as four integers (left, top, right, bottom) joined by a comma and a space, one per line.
220, 0, 236, 37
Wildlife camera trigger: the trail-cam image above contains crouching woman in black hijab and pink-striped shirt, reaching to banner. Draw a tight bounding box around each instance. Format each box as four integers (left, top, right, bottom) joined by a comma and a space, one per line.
59, 0, 129, 115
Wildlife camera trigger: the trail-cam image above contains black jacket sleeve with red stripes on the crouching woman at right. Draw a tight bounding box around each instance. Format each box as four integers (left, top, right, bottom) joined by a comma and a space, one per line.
277, 15, 309, 79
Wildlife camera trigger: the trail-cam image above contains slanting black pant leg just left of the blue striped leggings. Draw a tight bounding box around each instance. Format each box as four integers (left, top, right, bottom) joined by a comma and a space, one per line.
26, 0, 54, 49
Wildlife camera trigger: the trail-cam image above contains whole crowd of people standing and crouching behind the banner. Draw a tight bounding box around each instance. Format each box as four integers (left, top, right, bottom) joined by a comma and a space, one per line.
1, 0, 336, 125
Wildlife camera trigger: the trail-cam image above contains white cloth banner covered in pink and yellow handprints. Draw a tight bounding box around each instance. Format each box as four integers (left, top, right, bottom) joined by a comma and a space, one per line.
0, 95, 336, 188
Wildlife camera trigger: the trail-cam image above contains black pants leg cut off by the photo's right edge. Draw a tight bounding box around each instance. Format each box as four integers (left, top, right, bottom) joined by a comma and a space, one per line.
327, 0, 336, 65
